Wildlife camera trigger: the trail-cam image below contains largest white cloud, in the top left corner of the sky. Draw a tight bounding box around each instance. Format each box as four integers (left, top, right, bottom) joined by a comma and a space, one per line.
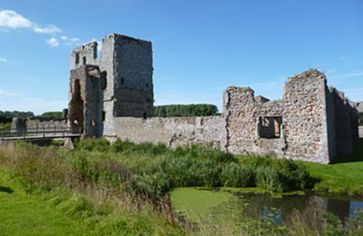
0, 10, 61, 34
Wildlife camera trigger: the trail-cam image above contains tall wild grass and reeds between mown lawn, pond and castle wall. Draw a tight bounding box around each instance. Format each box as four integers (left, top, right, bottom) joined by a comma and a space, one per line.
0, 139, 362, 235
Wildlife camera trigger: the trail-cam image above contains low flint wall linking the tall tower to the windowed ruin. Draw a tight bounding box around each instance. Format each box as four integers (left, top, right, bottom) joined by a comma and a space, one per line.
108, 116, 226, 150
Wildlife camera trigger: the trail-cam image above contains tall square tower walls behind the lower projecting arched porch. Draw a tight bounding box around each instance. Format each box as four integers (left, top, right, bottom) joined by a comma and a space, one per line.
71, 34, 154, 136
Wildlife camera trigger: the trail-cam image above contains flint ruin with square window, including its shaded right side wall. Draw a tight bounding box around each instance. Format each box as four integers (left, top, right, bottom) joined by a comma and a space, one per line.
224, 70, 357, 163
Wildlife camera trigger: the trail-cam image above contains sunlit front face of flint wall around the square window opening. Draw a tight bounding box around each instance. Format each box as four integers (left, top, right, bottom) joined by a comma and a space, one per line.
224, 71, 329, 163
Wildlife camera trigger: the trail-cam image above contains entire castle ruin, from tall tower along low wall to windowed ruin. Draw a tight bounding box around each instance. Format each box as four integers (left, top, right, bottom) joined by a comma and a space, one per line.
68, 34, 358, 163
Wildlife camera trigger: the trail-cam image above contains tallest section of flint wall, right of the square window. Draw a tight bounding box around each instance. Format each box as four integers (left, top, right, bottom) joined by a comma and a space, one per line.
283, 69, 330, 163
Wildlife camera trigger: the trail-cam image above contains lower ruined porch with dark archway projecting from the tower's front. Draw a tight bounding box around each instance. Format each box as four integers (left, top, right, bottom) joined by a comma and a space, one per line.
68, 65, 105, 137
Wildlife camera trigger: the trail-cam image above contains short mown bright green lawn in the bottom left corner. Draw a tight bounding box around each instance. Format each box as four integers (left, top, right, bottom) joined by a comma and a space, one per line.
0, 170, 93, 235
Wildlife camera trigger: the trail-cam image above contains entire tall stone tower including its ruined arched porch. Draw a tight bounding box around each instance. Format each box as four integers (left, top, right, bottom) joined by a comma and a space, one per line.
69, 34, 154, 137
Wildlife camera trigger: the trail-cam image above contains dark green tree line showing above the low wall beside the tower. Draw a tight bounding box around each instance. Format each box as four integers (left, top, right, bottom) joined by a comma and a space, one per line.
154, 104, 218, 117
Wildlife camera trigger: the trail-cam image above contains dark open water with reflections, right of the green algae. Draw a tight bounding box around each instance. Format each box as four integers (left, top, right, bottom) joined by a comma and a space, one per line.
238, 194, 363, 226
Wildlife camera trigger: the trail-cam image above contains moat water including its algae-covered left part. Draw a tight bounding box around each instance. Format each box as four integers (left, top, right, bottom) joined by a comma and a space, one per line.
175, 188, 363, 229
